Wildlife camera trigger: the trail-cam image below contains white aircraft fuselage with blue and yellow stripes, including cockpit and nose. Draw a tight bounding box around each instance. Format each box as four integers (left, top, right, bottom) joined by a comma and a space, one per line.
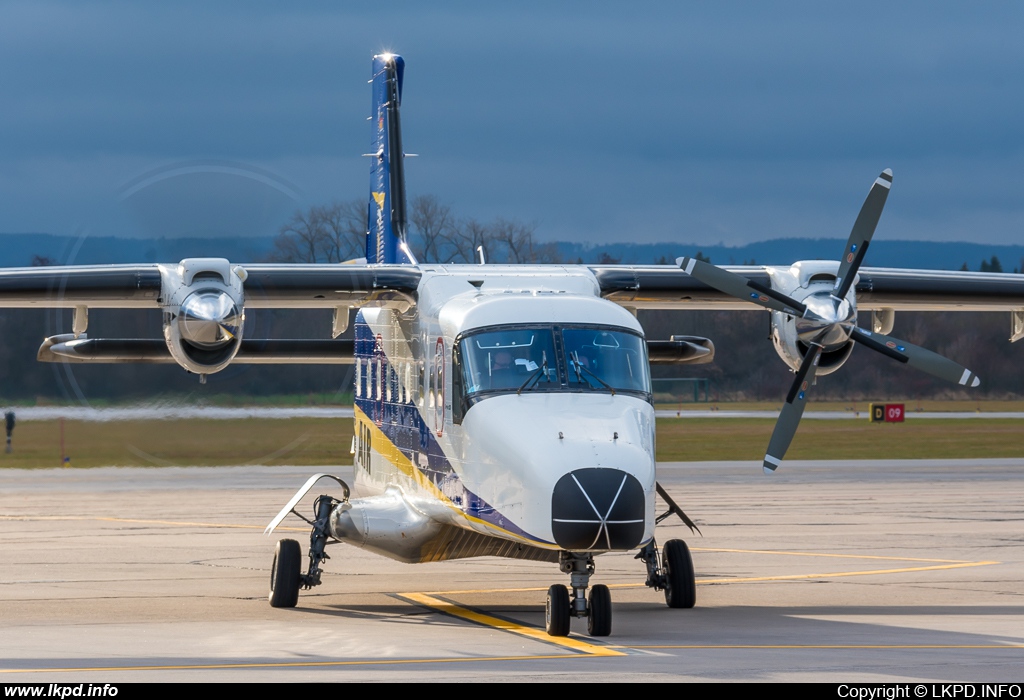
336, 265, 654, 561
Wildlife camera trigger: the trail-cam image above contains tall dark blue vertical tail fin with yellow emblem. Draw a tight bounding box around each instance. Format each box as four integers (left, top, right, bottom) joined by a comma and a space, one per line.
367, 53, 413, 263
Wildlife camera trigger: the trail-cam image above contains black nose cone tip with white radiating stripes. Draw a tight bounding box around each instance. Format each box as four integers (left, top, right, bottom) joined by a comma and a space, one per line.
551, 468, 644, 552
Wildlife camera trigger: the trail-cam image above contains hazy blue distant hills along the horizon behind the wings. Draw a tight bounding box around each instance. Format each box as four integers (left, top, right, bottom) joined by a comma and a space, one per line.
0, 233, 1024, 272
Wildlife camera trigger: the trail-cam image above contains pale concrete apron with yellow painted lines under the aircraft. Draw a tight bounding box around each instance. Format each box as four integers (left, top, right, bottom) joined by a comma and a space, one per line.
0, 460, 1024, 685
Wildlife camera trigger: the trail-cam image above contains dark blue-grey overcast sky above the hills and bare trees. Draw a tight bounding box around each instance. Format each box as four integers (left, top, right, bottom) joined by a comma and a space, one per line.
0, 2, 1024, 245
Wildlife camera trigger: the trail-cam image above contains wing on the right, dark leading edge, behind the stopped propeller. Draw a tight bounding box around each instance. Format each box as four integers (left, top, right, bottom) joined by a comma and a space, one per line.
590, 265, 1024, 311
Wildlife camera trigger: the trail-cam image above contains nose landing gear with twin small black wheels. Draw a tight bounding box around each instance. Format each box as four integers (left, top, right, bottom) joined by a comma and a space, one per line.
544, 552, 611, 637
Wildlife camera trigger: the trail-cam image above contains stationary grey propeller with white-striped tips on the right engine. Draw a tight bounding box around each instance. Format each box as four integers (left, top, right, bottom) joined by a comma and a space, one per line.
678, 168, 981, 474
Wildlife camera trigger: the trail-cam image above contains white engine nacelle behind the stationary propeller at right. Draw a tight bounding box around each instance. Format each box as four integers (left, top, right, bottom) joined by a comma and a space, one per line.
768, 260, 857, 376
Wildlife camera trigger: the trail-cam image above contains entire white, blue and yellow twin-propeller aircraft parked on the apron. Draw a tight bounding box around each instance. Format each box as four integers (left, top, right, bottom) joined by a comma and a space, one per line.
6, 54, 1024, 636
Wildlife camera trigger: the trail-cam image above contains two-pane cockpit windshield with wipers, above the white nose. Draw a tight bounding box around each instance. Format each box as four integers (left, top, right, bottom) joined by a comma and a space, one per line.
456, 324, 650, 407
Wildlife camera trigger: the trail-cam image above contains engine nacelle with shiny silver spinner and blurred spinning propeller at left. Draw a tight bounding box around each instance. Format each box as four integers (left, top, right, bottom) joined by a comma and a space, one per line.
160, 258, 246, 375
